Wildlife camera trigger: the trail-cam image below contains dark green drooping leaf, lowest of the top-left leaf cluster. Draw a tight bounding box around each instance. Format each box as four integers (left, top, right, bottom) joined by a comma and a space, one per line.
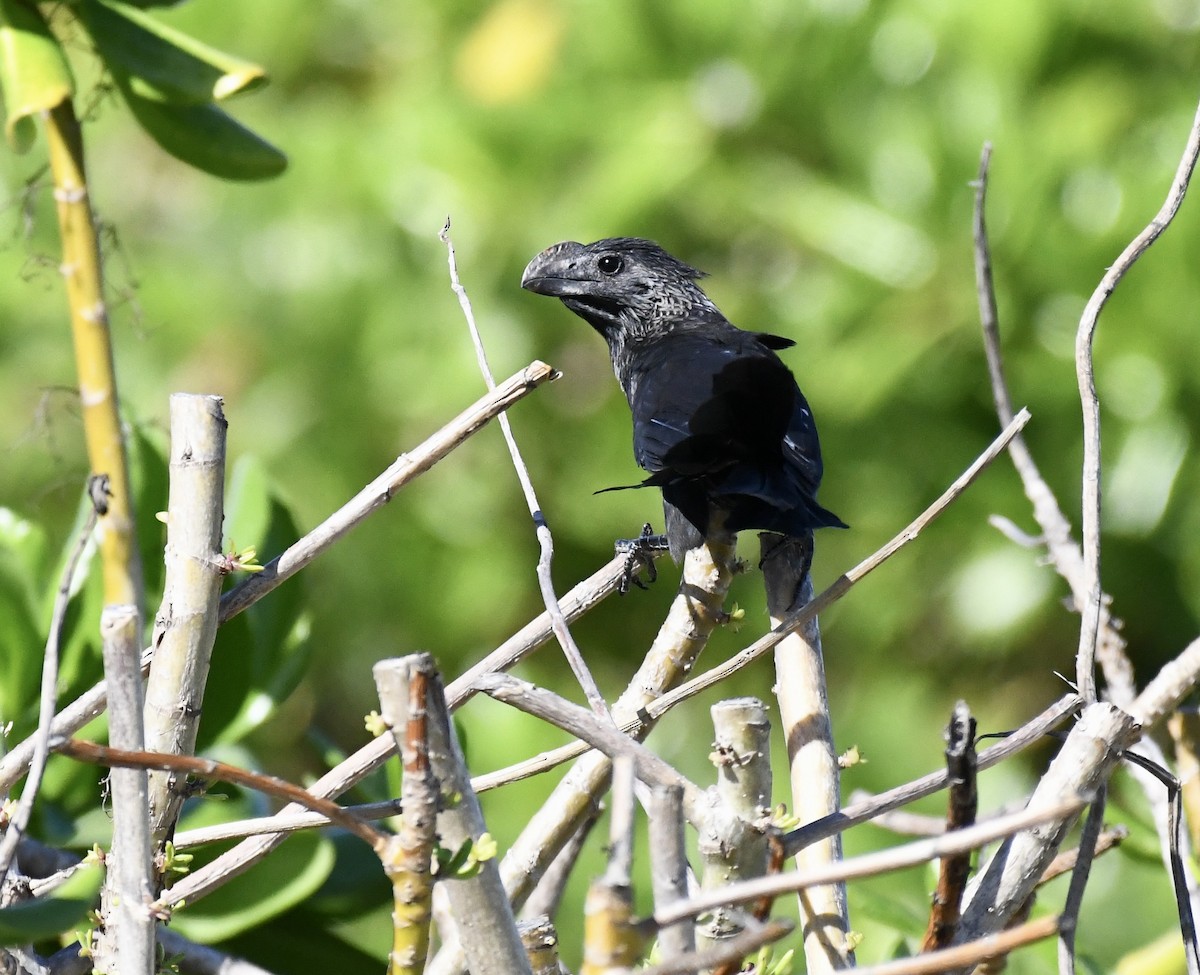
110, 65, 288, 180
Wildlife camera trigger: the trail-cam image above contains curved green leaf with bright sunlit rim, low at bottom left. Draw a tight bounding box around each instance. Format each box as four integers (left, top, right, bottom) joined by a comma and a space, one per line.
172, 833, 335, 944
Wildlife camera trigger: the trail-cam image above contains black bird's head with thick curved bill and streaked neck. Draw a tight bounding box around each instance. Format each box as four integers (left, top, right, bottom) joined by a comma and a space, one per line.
521, 237, 716, 342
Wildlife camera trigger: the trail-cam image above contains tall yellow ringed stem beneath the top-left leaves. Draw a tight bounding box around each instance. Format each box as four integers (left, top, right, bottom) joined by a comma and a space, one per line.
46, 98, 145, 614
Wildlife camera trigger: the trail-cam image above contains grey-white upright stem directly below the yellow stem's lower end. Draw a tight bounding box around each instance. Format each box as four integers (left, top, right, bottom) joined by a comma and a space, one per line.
95, 606, 157, 975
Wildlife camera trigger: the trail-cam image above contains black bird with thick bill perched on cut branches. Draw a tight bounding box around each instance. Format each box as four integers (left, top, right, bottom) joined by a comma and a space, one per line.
521, 238, 846, 602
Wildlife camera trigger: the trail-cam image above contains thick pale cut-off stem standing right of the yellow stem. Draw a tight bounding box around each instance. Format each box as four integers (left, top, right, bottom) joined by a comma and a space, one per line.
145, 393, 227, 844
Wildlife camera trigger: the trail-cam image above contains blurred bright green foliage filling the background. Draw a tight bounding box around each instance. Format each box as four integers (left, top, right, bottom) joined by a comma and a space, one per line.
0, 0, 1200, 971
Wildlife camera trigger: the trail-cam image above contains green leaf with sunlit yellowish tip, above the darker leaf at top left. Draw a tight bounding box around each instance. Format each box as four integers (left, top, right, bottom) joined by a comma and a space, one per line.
76, 0, 266, 104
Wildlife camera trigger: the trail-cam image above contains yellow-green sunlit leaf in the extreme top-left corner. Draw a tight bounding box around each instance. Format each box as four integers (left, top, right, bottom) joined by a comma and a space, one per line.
0, 0, 74, 152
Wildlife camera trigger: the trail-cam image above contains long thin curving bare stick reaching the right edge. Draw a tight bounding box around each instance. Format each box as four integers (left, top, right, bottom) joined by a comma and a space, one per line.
1075, 95, 1200, 704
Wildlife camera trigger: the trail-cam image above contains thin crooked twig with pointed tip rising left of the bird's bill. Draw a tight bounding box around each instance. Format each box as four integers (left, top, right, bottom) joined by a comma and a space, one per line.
442, 217, 611, 720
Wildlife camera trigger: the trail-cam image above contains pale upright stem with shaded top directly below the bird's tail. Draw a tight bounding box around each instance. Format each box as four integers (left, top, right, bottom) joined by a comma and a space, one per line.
760, 534, 854, 975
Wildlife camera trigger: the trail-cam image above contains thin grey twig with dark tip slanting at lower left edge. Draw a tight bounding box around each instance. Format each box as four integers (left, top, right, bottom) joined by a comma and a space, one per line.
0, 478, 99, 885
